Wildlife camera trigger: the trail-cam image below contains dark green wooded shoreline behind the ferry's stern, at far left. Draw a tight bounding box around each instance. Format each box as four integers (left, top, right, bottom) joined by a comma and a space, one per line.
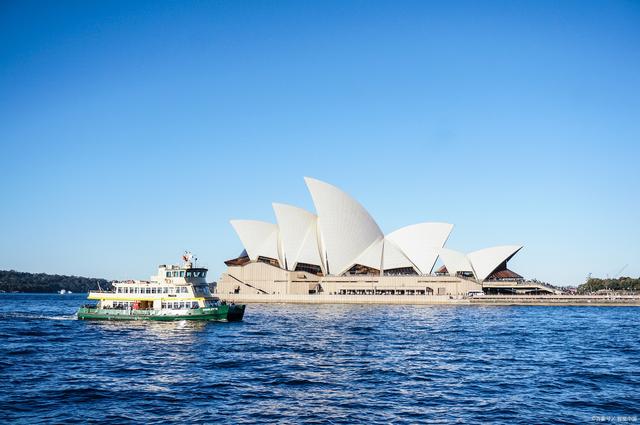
0, 270, 110, 292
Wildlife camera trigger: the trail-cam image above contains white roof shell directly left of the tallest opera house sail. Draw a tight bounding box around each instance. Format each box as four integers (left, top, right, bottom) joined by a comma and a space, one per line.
273, 203, 322, 270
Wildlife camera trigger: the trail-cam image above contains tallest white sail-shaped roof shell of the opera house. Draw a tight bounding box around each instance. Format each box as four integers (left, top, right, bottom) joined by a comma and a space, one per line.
305, 177, 384, 275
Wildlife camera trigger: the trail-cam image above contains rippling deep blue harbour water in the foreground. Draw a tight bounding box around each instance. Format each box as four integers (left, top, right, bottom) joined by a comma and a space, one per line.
0, 294, 640, 424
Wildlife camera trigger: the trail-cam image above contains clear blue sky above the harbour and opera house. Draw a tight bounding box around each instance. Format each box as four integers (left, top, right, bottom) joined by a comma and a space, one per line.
0, 1, 640, 284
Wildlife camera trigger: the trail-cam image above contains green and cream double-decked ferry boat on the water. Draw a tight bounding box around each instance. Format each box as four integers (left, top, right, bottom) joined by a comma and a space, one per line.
78, 252, 245, 322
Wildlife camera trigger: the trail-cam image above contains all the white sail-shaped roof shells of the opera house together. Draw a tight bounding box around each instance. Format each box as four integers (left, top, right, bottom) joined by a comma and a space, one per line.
231, 177, 522, 281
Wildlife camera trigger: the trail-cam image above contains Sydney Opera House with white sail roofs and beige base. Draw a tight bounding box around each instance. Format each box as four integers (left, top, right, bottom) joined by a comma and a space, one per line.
217, 178, 544, 296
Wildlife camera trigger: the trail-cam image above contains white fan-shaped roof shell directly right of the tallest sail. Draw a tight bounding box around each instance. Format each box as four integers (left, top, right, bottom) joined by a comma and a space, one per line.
385, 223, 453, 274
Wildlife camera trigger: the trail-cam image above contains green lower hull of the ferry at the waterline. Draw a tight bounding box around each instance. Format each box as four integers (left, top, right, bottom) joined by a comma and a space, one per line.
78, 304, 245, 322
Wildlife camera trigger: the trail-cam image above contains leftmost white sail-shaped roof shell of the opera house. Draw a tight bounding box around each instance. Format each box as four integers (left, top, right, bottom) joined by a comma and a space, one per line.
231, 220, 282, 264
